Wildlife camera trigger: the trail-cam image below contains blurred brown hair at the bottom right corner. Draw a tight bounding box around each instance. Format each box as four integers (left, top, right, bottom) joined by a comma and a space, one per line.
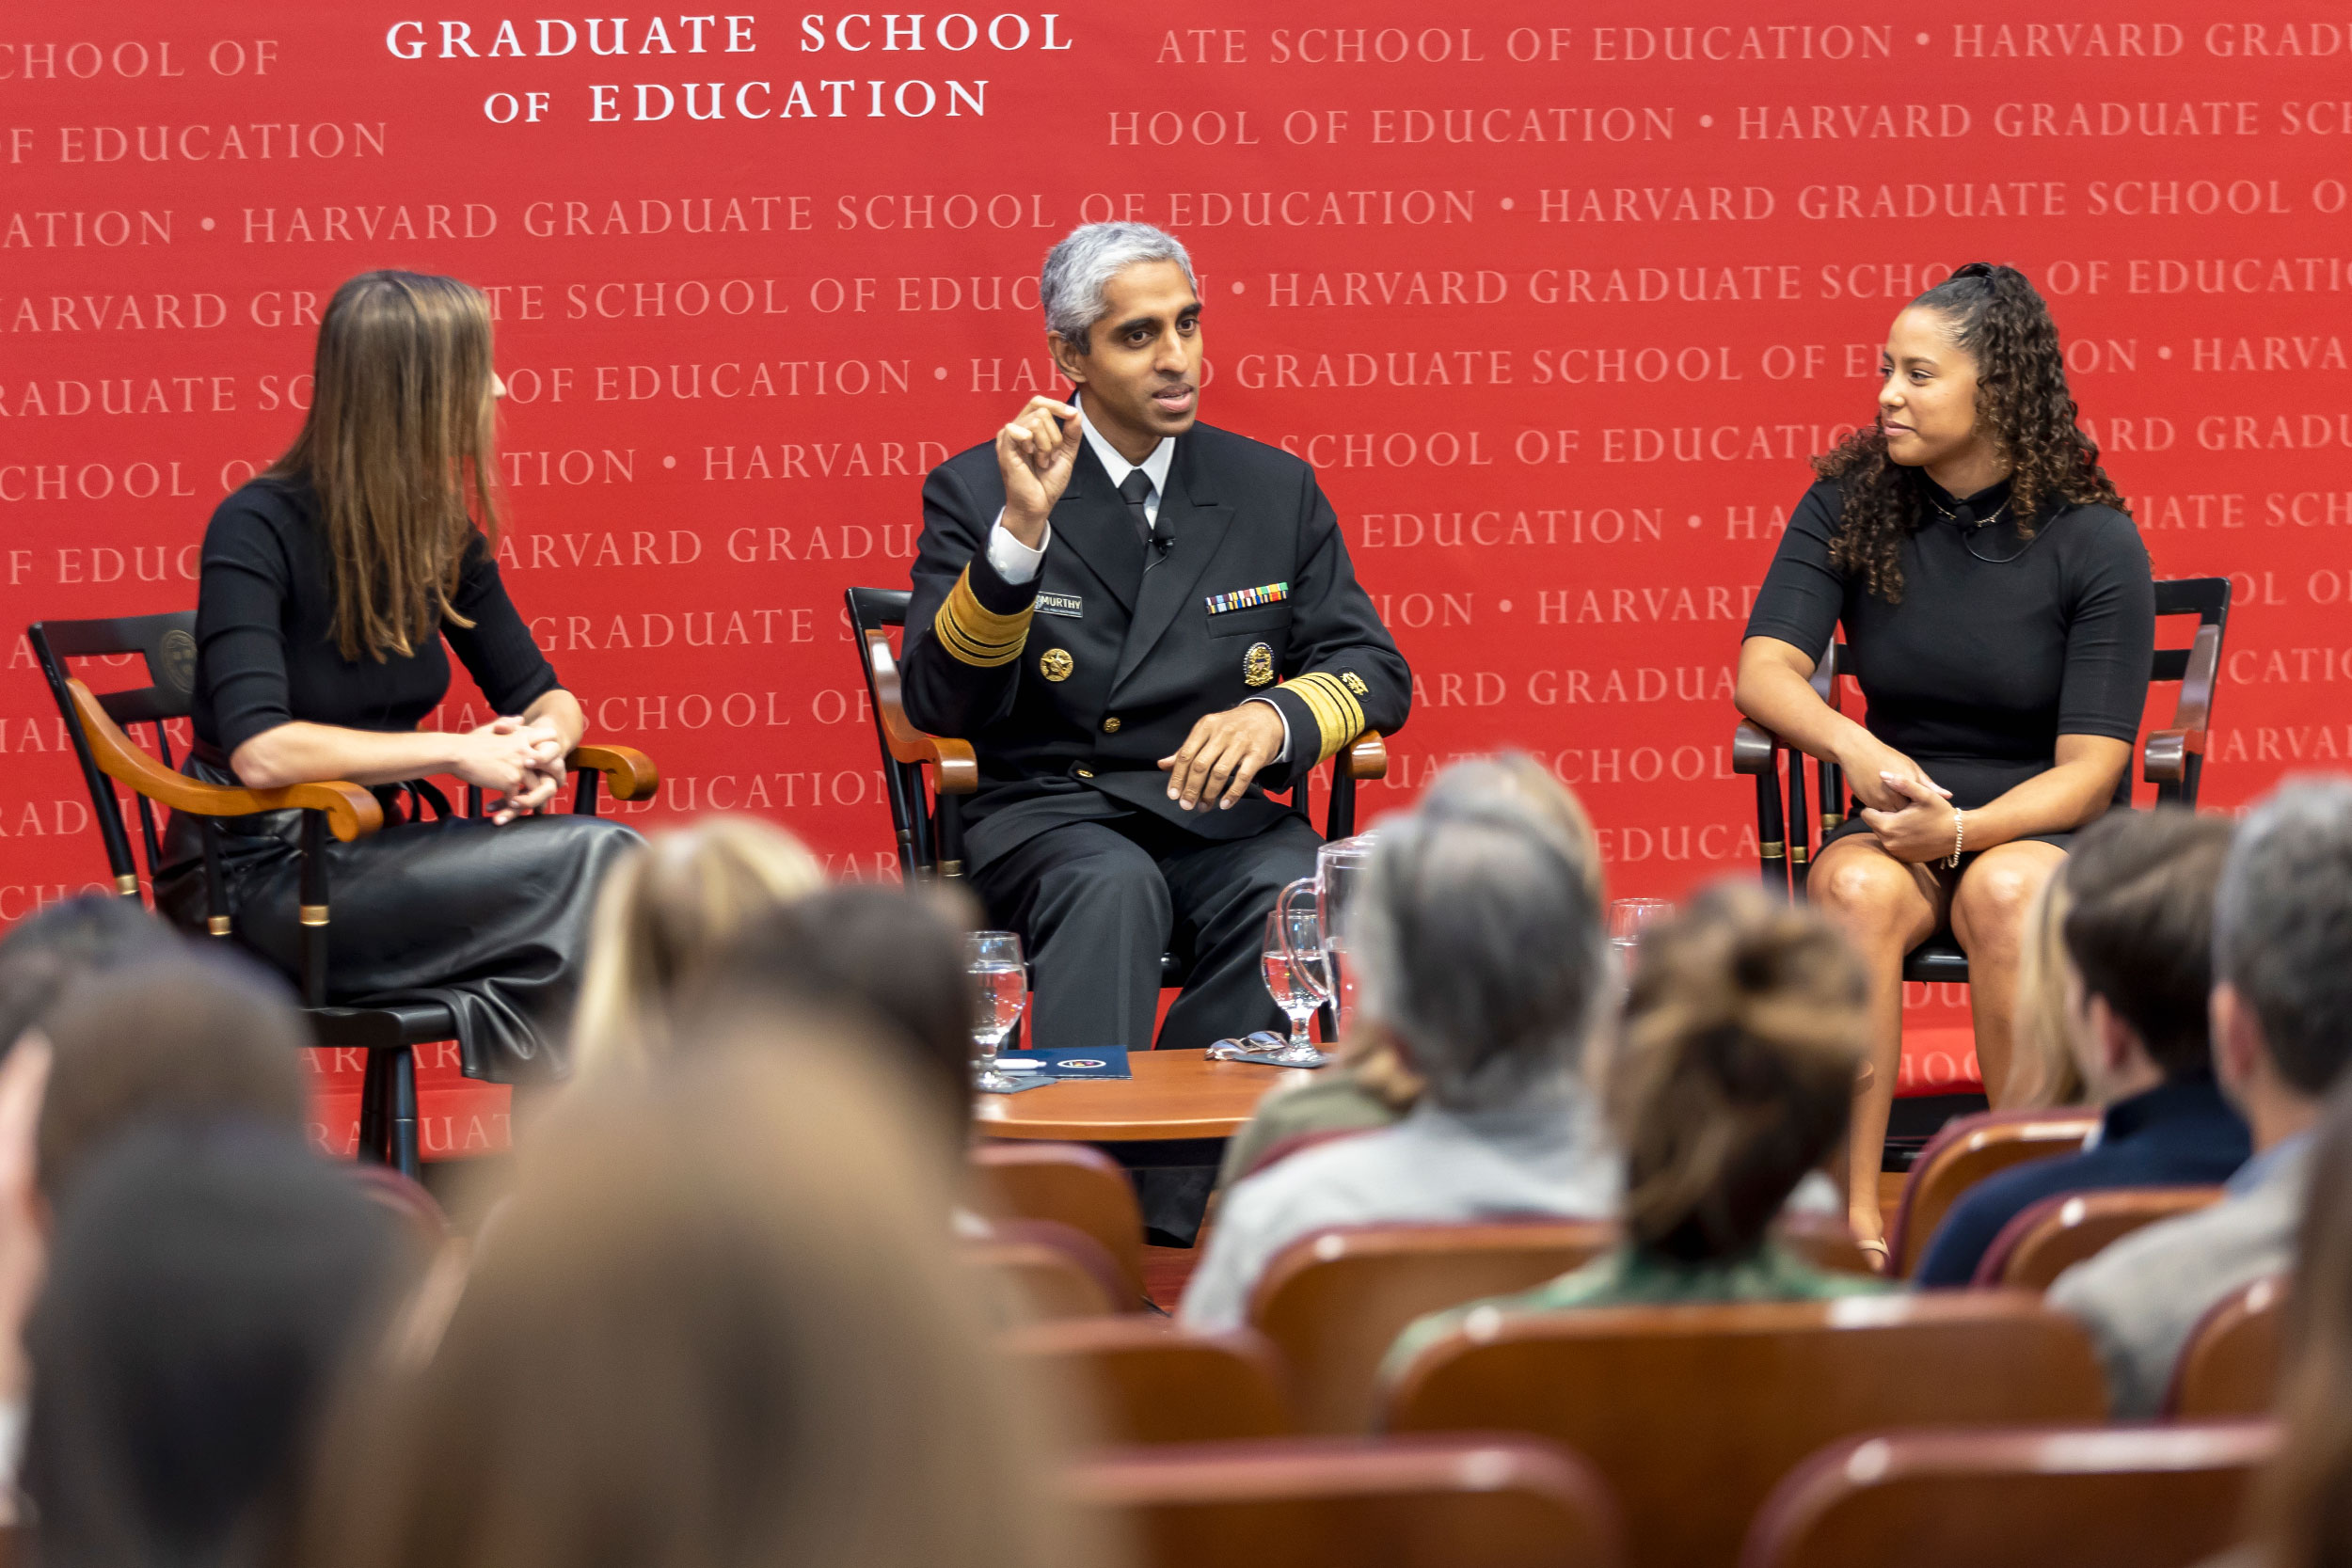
2233, 1091, 2352, 1568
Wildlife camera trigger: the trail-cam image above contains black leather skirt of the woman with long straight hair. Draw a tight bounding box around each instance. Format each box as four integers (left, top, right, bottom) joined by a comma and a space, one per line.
155, 757, 643, 1084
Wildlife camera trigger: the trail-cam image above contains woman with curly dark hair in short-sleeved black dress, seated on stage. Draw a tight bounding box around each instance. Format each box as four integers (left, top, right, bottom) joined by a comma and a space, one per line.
1739, 261, 2154, 1243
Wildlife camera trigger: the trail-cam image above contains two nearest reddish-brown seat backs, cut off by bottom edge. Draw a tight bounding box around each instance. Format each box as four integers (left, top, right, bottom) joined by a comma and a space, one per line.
1073, 1422, 2277, 1568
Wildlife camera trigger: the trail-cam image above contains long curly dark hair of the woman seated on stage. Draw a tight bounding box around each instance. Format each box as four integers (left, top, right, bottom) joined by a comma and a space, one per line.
1814, 261, 2129, 604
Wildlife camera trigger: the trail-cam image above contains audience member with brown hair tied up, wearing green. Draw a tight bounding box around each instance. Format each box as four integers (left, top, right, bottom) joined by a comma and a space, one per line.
1381, 881, 1889, 1383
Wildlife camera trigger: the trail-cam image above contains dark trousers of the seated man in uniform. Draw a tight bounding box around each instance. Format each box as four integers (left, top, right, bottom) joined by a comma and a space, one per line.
972, 811, 1322, 1051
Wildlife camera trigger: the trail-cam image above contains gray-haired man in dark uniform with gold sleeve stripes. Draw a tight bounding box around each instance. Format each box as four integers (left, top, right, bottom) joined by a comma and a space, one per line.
901, 223, 1411, 1049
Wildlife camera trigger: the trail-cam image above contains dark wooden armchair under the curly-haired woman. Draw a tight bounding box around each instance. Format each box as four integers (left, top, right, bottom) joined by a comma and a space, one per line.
1731, 576, 2230, 985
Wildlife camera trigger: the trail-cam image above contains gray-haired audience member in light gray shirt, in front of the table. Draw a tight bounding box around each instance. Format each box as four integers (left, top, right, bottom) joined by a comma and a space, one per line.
1181, 792, 1621, 1328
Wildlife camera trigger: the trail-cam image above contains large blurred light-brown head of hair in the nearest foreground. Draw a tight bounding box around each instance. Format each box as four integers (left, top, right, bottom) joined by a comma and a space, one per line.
306, 1043, 1118, 1568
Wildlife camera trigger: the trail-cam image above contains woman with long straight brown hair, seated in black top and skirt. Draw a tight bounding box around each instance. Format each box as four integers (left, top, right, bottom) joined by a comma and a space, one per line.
155, 273, 638, 1082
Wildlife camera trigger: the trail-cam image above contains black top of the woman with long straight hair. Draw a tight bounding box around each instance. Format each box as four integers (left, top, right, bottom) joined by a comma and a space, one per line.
193, 477, 563, 757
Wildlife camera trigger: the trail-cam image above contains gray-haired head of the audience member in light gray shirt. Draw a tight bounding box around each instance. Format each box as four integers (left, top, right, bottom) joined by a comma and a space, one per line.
1348, 771, 1607, 1112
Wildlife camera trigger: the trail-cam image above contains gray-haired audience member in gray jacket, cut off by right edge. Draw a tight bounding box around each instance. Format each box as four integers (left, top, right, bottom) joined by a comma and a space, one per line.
2049, 778, 2352, 1418
